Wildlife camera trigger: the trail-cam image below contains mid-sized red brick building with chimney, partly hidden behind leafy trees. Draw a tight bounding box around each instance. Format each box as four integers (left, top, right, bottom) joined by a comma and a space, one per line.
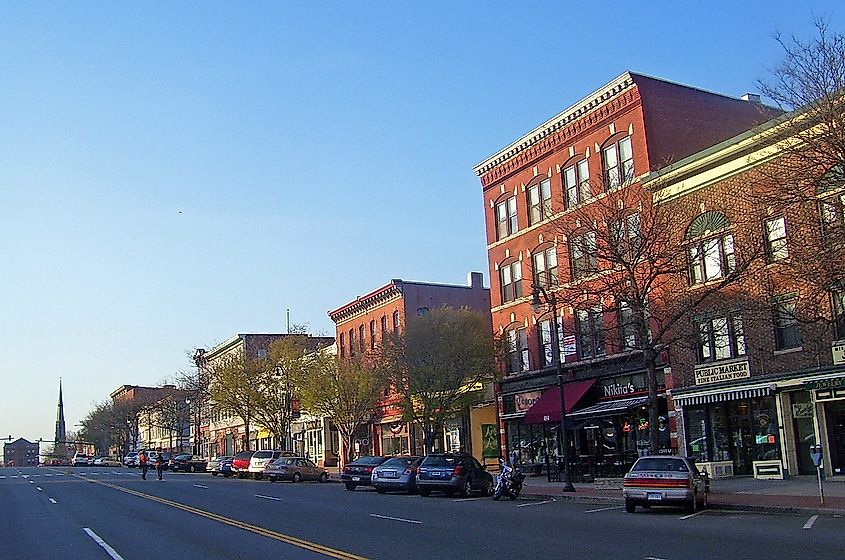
329, 272, 495, 460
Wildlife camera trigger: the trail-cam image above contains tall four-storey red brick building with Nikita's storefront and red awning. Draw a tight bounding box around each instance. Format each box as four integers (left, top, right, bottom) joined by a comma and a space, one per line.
474, 72, 776, 476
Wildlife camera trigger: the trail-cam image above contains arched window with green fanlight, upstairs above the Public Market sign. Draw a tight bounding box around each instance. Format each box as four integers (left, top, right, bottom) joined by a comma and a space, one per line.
685, 211, 736, 285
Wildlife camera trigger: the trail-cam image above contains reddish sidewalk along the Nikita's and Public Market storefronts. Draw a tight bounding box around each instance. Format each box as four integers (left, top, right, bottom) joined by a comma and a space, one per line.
522, 476, 845, 515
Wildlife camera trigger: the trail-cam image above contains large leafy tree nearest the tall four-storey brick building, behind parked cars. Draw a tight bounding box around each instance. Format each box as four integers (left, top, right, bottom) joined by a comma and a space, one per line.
378, 307, 501, 453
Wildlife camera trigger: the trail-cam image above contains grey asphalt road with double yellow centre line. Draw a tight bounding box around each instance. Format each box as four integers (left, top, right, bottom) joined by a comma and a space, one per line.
0, 467, 845, 560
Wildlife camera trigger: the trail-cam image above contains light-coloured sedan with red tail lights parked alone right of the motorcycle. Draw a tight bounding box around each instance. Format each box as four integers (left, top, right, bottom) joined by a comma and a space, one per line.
622, 455, 710, 513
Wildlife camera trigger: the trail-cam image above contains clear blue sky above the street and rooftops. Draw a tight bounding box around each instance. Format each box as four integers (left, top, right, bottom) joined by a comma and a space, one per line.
0, 1, 843, 446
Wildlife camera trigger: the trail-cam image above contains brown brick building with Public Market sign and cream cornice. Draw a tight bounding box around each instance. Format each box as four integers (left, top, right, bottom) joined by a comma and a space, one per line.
645, 115, 845, 478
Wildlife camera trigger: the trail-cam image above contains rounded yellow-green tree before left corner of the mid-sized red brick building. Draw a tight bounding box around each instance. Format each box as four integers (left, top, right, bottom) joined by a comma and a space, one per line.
299, 350, 387, 463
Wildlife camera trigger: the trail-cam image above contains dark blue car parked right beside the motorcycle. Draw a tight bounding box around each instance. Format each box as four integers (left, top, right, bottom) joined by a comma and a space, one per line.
417, 453, 494, 496
